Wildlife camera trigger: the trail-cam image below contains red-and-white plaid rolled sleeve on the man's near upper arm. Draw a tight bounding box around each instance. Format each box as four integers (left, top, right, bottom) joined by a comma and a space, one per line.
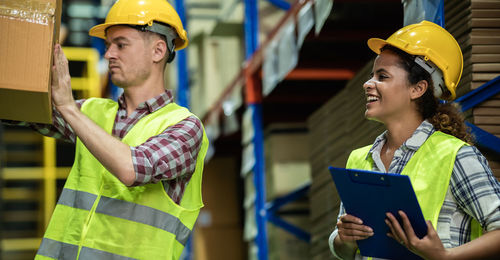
131, 116, 203, 186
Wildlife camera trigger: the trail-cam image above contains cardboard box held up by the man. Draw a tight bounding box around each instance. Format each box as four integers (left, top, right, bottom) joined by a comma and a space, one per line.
0, 0, 62, 123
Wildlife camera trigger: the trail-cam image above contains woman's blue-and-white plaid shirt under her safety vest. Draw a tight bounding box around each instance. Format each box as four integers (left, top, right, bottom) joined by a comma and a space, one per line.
329, 121, 500, 259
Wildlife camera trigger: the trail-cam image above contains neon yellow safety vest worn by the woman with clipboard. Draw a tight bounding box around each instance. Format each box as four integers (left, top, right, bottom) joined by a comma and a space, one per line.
346, 131, 481, 242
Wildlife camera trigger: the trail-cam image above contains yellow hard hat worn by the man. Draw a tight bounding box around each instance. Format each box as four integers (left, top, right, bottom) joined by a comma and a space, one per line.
89, 0, 188, 50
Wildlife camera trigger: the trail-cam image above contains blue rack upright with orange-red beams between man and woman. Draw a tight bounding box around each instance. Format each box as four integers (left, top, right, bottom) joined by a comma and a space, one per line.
204, 1, 354, 259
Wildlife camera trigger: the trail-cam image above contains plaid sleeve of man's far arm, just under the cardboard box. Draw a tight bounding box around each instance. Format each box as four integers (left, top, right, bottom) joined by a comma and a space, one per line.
5, 99, 85, 143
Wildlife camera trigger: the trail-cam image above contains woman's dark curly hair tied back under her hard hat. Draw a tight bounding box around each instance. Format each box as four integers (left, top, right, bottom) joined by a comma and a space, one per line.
380, 45, 473, 144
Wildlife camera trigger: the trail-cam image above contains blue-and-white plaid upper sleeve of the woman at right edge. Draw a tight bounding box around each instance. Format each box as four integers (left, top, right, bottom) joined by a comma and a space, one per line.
450, 146, 500, 231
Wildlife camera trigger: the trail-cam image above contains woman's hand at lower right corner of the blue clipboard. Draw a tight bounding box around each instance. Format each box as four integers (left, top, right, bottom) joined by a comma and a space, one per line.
385, 211, 449, 259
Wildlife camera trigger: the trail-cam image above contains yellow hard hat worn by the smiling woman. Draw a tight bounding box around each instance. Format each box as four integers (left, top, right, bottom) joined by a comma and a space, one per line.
368, 21, 463, 100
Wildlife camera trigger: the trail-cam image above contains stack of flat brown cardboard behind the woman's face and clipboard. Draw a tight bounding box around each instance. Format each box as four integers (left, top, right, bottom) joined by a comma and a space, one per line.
308, 63, 383, 260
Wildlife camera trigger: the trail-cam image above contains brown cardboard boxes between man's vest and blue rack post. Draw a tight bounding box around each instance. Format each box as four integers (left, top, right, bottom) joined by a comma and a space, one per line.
193, 157, 246, 260
